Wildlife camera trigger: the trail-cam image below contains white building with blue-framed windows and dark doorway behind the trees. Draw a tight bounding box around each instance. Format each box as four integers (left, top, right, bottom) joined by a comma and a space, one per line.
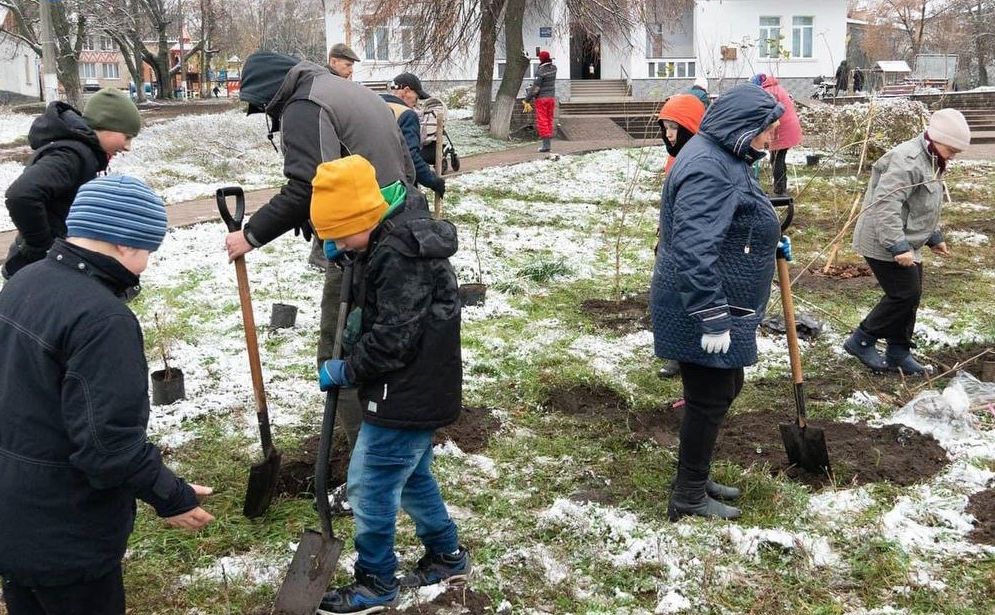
325, 0, 847, 100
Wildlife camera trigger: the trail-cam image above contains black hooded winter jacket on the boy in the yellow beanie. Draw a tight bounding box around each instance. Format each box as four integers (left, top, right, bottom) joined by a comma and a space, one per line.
347, 187, 463, 429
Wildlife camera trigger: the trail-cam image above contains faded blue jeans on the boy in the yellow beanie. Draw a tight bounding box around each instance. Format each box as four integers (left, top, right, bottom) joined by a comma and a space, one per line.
348, 422, 459, 579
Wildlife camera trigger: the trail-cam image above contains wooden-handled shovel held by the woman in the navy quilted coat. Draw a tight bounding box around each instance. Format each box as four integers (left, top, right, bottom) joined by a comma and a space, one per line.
771, 197, 831, 474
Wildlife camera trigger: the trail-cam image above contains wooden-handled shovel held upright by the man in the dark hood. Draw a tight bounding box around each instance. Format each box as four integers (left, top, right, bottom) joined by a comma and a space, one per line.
217, 186, 281, 519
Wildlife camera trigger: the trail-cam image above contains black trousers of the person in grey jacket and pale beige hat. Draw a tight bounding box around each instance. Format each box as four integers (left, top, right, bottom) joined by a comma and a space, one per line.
860, 257, 922, 348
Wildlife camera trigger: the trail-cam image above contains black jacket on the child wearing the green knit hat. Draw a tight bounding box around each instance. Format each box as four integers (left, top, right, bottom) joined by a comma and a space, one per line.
4, 101, 107, 278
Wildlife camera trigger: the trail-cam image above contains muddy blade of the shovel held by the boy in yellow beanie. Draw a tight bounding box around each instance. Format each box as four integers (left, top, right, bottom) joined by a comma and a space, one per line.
273, 530, 344, 615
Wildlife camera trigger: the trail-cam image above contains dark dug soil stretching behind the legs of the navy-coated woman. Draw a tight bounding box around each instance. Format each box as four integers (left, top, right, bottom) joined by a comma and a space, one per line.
547, 385, 949, 488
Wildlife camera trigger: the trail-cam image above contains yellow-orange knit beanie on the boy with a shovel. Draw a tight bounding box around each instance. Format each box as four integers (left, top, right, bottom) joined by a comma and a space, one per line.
311, 155, 387, 239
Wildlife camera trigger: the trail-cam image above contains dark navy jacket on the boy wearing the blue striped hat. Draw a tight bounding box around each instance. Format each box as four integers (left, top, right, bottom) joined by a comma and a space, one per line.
0, 240, 197, 587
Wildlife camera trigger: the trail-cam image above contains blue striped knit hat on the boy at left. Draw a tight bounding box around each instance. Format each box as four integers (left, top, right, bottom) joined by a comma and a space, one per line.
66, 175, 166, 252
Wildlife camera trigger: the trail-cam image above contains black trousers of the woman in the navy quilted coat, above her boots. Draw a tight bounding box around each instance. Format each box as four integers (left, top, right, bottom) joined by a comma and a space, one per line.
677, 363, 743, 481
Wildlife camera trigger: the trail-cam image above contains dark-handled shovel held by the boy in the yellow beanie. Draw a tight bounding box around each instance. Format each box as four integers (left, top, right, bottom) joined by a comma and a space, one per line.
273, 253, 352, 615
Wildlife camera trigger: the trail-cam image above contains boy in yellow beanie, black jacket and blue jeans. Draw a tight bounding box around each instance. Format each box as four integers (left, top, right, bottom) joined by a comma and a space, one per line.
311, 156, 470, 614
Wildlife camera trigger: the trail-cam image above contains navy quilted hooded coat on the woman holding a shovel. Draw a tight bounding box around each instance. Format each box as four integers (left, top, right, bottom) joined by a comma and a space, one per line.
650, 84, 784, 368
